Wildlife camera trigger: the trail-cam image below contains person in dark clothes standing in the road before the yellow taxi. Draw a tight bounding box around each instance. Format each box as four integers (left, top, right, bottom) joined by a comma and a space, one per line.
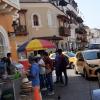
55, 49, 69, 85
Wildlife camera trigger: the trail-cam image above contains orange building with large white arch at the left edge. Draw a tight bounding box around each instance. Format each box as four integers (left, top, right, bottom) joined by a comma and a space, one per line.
0, 0, 19, 59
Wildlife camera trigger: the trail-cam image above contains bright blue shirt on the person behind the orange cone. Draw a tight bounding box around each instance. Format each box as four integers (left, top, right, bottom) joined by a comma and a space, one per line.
30, 63, 40, 86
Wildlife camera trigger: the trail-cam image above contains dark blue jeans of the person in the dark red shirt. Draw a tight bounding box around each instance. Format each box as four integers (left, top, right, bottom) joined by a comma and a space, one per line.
46, 72, 54, 92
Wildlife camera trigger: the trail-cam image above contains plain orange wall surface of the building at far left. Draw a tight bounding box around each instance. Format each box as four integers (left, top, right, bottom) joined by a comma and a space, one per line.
0, 15, 18, 61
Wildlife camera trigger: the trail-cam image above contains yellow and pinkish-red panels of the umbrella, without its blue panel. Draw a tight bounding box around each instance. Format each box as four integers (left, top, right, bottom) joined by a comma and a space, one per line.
26, 39, 56, 51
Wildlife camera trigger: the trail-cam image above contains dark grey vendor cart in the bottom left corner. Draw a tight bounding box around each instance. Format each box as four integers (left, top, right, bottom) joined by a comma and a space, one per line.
0, 78, 21, 100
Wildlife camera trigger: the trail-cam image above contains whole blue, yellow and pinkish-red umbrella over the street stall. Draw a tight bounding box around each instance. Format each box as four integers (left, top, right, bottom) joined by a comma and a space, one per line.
17, 39, 56, 52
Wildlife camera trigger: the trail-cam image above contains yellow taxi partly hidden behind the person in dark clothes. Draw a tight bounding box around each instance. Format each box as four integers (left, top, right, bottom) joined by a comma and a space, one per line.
49, 51, 76, 68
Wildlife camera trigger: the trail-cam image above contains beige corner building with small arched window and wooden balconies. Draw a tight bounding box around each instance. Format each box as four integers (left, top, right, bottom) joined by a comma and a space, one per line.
15, 0, 83, 54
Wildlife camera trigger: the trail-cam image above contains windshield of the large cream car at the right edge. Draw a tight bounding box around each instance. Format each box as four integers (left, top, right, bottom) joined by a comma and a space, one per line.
83, 51, 100, 60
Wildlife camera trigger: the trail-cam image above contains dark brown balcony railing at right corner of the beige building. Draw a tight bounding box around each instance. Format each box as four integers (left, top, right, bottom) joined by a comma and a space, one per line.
59, 26, 71, 37
